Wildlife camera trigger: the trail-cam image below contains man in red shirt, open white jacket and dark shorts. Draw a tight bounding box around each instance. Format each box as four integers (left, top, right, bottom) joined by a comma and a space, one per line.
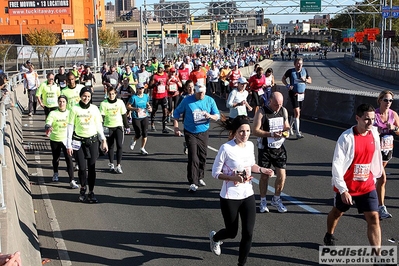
324, 104, 383, 247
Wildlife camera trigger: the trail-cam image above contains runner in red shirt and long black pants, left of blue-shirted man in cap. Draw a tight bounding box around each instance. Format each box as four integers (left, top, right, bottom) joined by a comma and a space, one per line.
150, 64, 169, 133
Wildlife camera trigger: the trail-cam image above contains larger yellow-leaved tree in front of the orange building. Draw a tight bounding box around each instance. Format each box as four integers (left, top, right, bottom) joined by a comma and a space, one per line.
26, 28, 60, 68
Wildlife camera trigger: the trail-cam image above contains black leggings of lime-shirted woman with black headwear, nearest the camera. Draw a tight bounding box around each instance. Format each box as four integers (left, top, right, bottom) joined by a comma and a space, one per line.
74, 141, 99, 191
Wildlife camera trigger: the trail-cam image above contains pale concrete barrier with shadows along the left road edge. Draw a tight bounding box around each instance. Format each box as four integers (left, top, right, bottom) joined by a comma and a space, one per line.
0, 103, 41, 265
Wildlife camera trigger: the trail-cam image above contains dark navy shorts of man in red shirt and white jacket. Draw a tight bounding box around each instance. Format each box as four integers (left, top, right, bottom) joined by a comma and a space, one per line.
334, 189, 378, 213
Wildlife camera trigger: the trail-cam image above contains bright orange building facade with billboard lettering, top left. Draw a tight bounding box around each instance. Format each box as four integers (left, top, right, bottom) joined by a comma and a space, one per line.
0, 0, 105, 43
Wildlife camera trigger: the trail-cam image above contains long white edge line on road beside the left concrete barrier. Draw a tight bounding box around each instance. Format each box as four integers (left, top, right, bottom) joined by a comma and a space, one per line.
35, 151, 72, 266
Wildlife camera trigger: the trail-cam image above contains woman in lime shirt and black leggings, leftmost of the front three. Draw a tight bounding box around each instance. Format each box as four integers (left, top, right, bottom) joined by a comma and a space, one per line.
45, 95, 79, 188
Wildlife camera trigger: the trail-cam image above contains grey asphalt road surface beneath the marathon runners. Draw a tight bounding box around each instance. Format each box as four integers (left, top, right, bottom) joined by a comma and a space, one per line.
28, 53, 399, 266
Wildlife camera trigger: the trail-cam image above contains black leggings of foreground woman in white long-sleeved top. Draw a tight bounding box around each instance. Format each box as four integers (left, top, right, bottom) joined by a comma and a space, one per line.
213, 195, 256, 265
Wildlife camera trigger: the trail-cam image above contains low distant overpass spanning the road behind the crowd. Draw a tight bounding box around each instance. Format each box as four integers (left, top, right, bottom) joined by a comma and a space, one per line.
227, 32, 332, 45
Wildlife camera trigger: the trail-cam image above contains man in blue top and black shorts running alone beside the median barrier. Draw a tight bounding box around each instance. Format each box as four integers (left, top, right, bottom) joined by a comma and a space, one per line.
281, 57, 312, 139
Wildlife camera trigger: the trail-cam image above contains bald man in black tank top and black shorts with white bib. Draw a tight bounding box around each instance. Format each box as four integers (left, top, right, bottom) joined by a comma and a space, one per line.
253, 92, 290, 213
